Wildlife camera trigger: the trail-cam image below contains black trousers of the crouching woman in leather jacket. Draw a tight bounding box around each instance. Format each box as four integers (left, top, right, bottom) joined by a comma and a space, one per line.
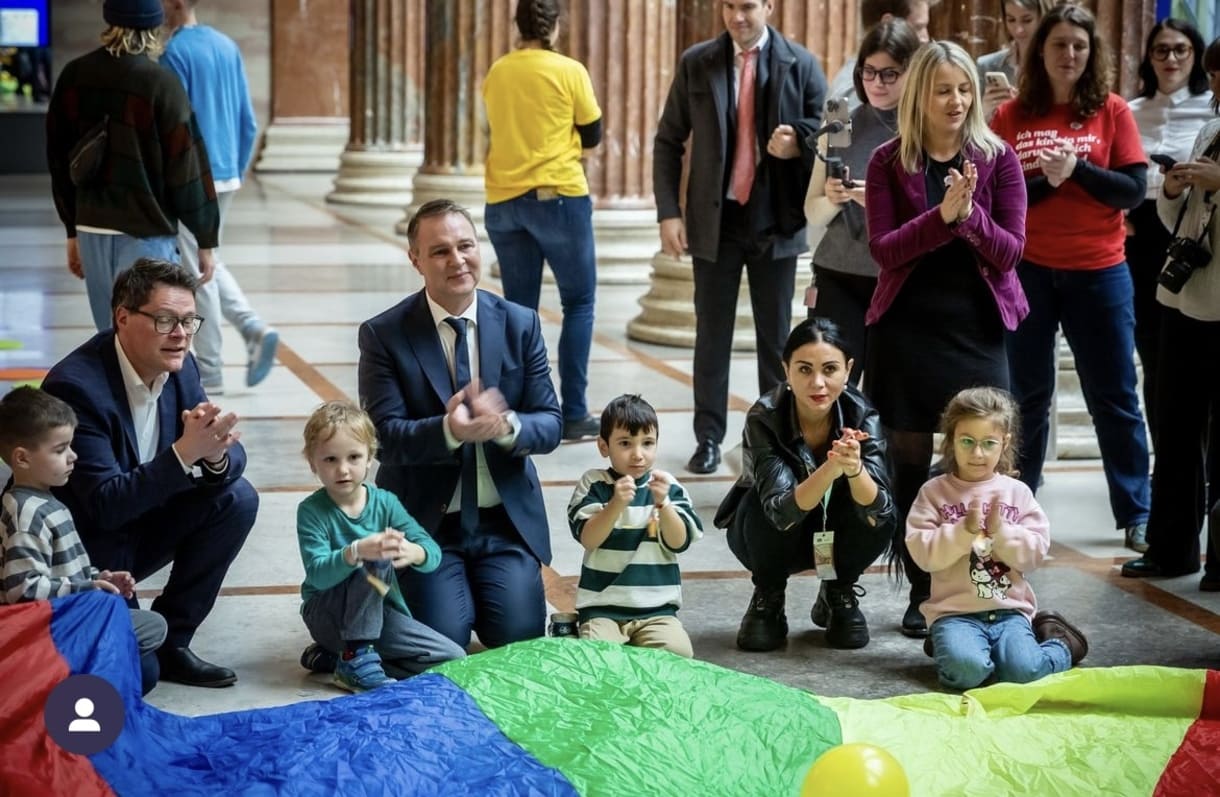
727, 489, 893, 590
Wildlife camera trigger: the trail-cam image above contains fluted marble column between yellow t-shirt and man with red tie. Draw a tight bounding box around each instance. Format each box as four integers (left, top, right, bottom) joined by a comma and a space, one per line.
560, 0, 677, 284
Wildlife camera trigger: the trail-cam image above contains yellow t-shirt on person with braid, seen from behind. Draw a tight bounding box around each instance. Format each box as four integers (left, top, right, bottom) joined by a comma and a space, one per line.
483, 49, 601, 203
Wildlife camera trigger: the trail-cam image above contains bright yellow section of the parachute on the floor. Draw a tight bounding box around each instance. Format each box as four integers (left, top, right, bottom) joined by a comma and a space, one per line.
820, 666, 1205, 797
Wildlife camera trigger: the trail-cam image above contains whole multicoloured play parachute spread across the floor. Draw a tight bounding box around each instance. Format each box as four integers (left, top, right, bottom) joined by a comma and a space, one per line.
0, 592, 1220, 797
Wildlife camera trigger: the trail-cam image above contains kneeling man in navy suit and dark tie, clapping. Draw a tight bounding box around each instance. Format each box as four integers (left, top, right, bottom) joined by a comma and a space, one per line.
360, 199, 562, 647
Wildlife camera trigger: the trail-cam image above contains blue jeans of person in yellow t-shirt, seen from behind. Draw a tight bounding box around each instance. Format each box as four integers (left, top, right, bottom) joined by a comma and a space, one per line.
483, 190, 598, 421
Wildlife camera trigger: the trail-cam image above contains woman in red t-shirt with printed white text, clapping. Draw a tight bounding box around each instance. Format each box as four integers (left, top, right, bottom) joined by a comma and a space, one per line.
992, 5, 1149, 552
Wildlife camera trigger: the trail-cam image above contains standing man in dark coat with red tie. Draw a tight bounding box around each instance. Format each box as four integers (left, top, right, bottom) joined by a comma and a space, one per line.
653, 0, 826, 474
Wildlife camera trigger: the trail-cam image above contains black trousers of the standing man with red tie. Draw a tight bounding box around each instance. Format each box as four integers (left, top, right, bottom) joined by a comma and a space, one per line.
693, 200, 797, 444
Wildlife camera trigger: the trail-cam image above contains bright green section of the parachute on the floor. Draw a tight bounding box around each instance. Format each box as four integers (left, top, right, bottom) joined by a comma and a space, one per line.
434, 640, 842, 797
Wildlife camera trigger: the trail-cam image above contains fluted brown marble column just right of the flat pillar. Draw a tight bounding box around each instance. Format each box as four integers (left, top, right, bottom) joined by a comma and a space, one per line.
327, 0, 425, 206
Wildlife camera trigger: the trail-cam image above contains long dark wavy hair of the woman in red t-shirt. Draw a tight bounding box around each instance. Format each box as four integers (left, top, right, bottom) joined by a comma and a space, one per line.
1016, 5, 1113, 118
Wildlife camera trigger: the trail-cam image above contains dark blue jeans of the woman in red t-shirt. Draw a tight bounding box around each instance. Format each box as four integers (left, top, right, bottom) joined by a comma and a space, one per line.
1008, 261, 1150, 528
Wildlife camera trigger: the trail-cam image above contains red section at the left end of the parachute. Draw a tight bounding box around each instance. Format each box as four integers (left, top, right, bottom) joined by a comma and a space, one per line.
0, 600, 113, 797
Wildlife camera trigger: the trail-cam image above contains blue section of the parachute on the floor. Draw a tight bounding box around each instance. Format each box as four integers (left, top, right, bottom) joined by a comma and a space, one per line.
51, 592, 577, 797
